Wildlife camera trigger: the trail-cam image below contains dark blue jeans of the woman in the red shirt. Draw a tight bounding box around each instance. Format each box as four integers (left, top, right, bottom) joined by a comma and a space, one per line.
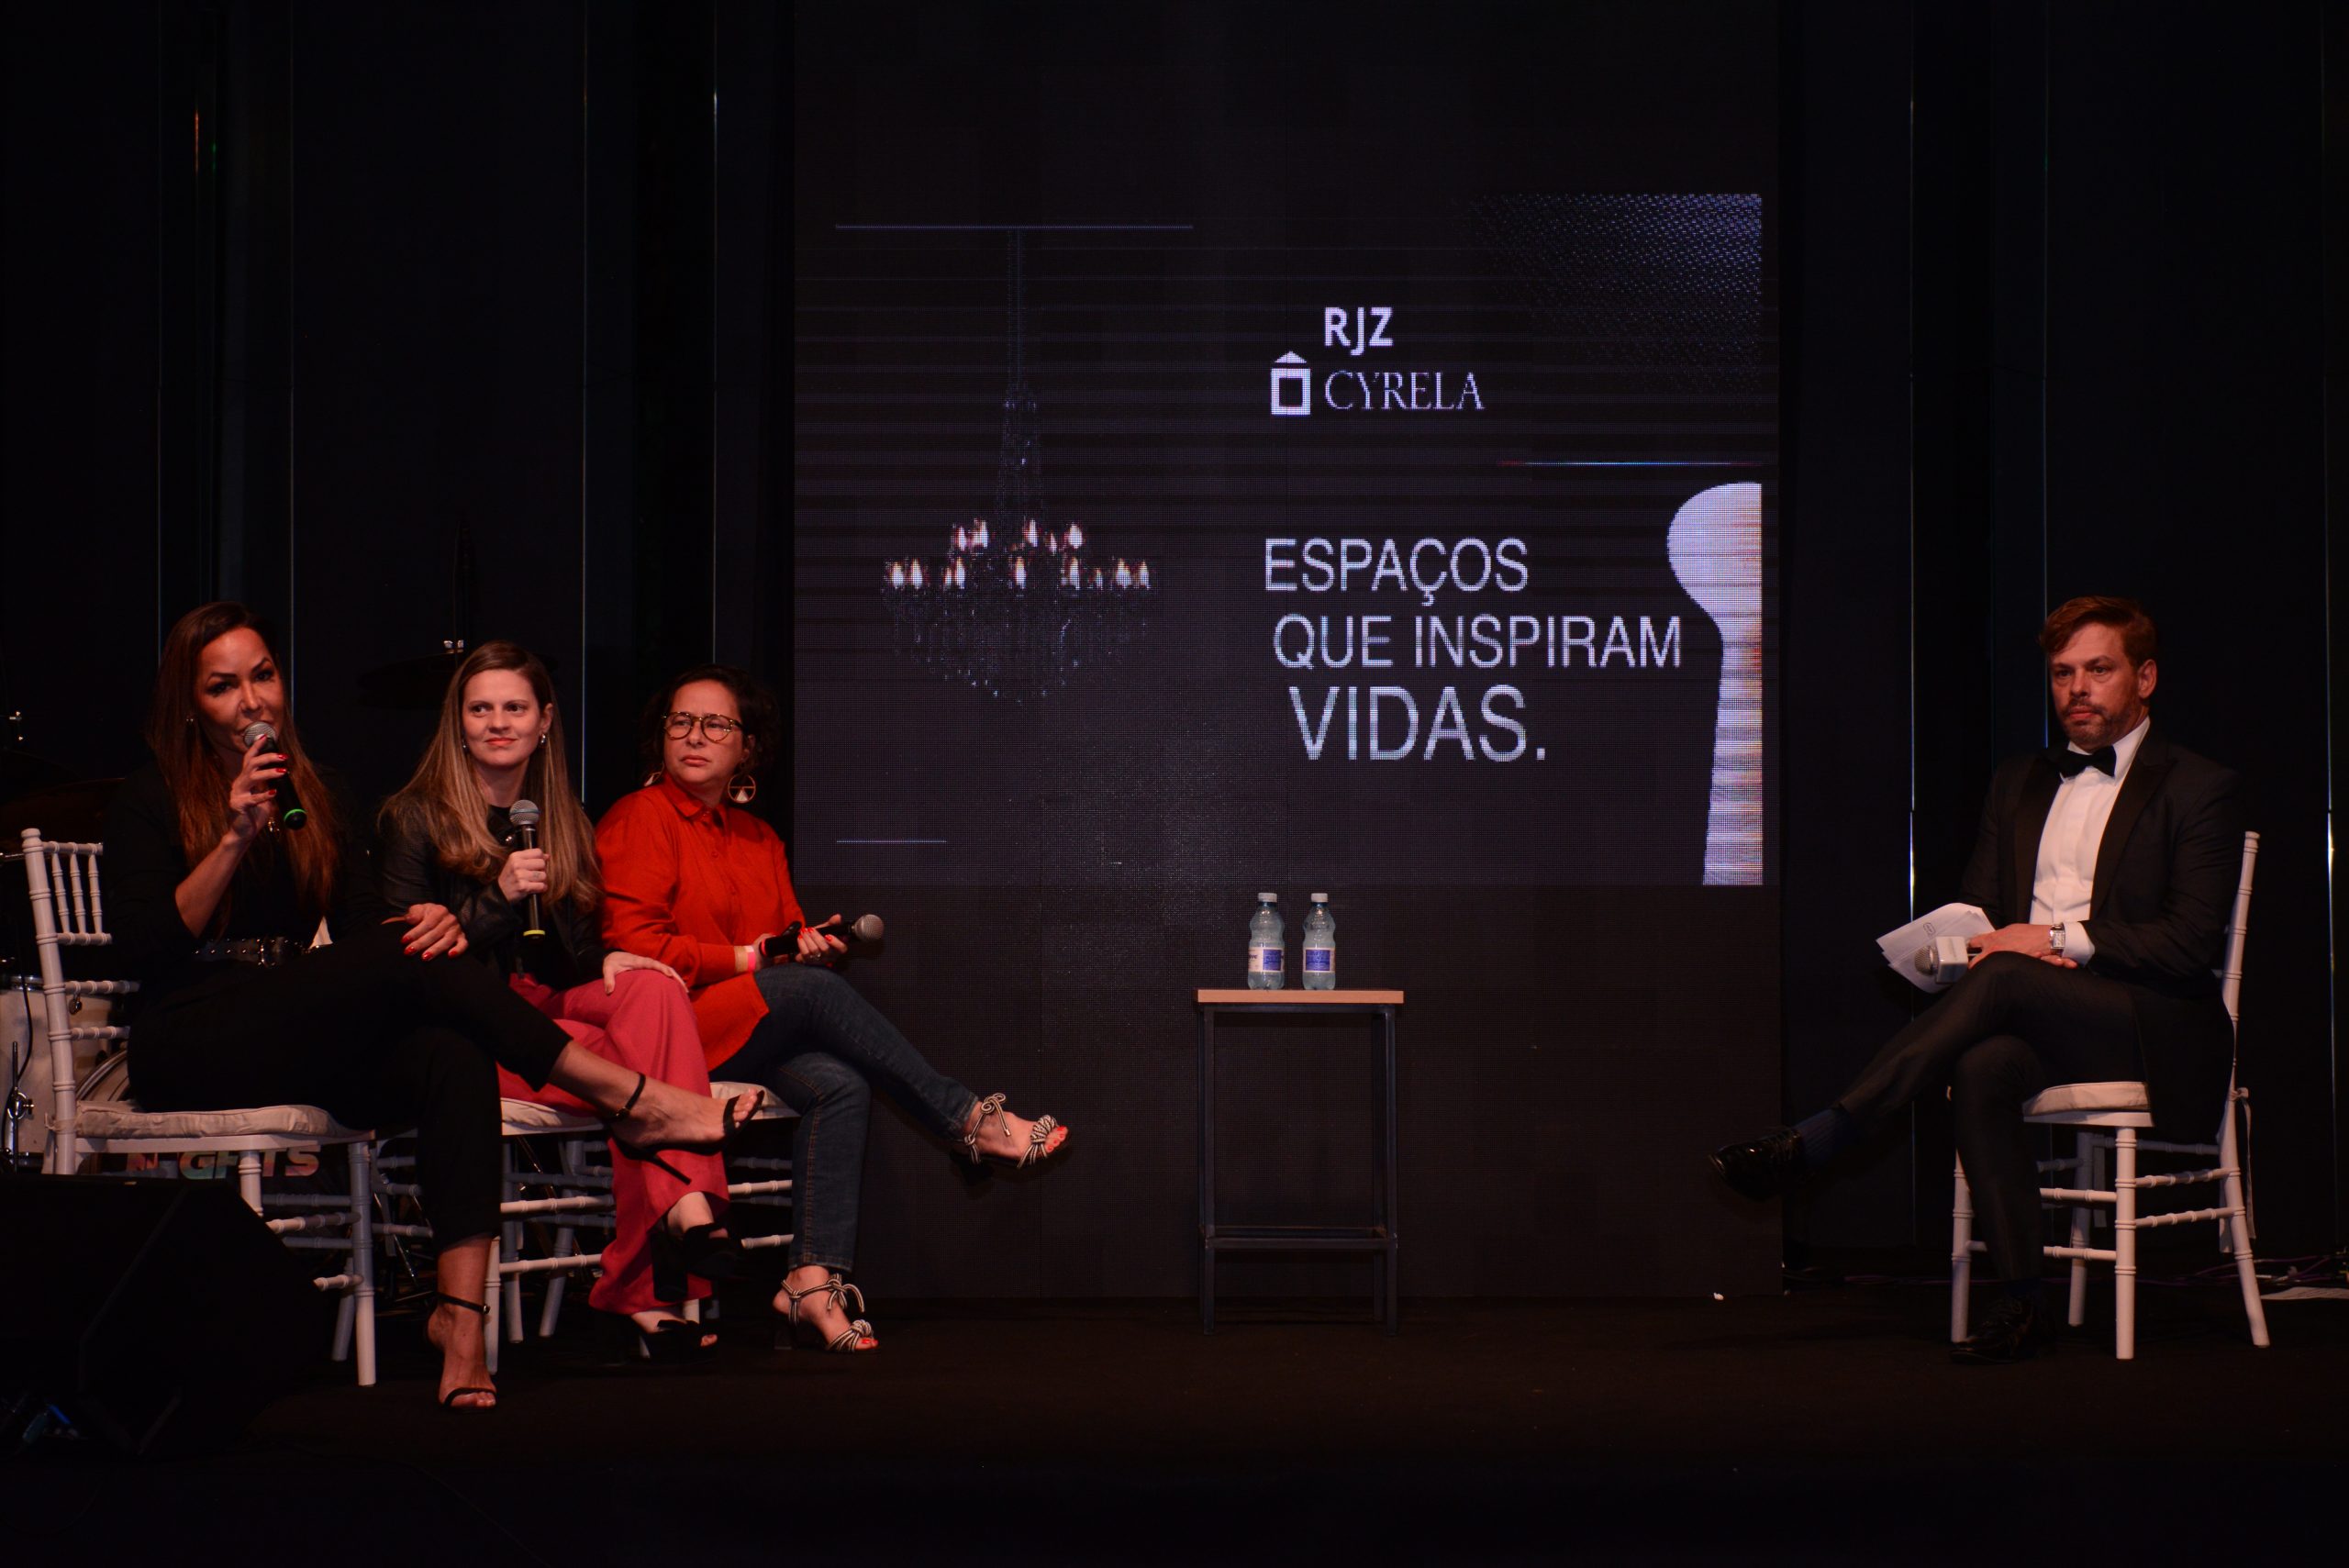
709, 964, 980, 1270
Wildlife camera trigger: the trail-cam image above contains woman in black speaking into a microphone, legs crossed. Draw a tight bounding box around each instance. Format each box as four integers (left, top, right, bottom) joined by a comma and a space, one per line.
106, 604, 730, 1408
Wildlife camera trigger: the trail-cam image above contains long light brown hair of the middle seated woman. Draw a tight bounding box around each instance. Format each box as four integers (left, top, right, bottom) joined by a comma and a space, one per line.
383, 640, 604, 908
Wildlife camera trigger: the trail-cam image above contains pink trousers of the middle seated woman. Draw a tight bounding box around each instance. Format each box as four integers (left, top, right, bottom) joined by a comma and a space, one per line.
498, 970, 726, 1312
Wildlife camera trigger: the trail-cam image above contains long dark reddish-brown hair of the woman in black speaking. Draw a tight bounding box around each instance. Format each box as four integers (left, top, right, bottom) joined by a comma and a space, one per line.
146, 598, 343, 922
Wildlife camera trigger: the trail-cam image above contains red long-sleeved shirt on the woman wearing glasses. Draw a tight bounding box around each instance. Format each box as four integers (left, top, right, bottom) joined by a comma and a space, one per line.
595, 773, 806, 1071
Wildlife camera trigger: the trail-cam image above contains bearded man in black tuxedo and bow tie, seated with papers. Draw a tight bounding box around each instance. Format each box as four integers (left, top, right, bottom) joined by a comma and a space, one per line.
1712, 596, 2243, 1362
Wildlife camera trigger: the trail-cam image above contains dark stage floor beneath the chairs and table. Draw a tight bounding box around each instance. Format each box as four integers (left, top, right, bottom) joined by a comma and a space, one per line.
0, 1284, 2349, 1565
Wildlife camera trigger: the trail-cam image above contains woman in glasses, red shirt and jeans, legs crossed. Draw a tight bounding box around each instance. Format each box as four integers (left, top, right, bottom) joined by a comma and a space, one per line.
596, 664, 1069, 1350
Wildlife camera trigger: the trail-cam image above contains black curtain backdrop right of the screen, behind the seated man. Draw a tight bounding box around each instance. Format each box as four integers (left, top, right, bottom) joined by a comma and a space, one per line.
1786, 3, 2342, 1265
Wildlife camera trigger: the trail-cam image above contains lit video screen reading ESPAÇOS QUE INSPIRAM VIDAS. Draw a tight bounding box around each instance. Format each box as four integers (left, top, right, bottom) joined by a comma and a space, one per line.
794, 193, 1776, 887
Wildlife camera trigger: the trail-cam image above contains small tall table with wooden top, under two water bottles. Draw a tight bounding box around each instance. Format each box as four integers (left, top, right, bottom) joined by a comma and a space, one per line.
1198, 991, 1402, 1333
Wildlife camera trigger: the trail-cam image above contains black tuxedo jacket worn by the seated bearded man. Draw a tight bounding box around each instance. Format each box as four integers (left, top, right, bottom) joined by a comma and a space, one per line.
1962, 726, 2243, 1139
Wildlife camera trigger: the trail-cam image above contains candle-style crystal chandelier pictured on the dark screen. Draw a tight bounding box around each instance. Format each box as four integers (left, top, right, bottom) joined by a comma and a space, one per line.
881, 232, 1158, 702
